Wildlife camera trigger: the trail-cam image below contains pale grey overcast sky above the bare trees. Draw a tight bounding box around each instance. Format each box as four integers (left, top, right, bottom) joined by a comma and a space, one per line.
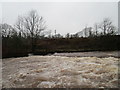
2, 2, 118, 34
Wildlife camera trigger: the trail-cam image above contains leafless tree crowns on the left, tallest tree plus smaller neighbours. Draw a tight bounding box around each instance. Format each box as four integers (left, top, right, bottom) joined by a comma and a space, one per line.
0, 10, 46, 38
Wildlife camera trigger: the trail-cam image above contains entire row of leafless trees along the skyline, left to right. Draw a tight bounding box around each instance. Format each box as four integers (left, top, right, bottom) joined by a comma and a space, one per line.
0, 10, 117, 51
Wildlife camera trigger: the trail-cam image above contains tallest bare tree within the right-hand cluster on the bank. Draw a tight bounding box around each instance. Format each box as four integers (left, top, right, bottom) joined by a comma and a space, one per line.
99, 18, 115, 35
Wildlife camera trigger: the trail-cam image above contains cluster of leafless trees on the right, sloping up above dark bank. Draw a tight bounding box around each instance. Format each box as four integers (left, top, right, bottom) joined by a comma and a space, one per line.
77, 18, 118, 37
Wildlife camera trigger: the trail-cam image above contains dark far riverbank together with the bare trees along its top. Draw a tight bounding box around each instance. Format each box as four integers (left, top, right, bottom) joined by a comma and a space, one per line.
0, 10, 120, 58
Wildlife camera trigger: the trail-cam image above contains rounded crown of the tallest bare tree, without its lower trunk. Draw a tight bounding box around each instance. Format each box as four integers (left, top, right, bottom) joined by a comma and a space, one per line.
25, 10, 46, 37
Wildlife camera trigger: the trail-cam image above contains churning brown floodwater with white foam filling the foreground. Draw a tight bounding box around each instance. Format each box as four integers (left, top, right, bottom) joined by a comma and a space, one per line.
2, 56, 118, 88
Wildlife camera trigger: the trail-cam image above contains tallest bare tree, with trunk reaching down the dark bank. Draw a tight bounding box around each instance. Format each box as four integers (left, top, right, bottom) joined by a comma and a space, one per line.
16, 10, 46, 52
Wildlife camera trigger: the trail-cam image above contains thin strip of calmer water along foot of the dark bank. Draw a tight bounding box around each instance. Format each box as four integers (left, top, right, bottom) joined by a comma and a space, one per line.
2, 51, 120, 58
